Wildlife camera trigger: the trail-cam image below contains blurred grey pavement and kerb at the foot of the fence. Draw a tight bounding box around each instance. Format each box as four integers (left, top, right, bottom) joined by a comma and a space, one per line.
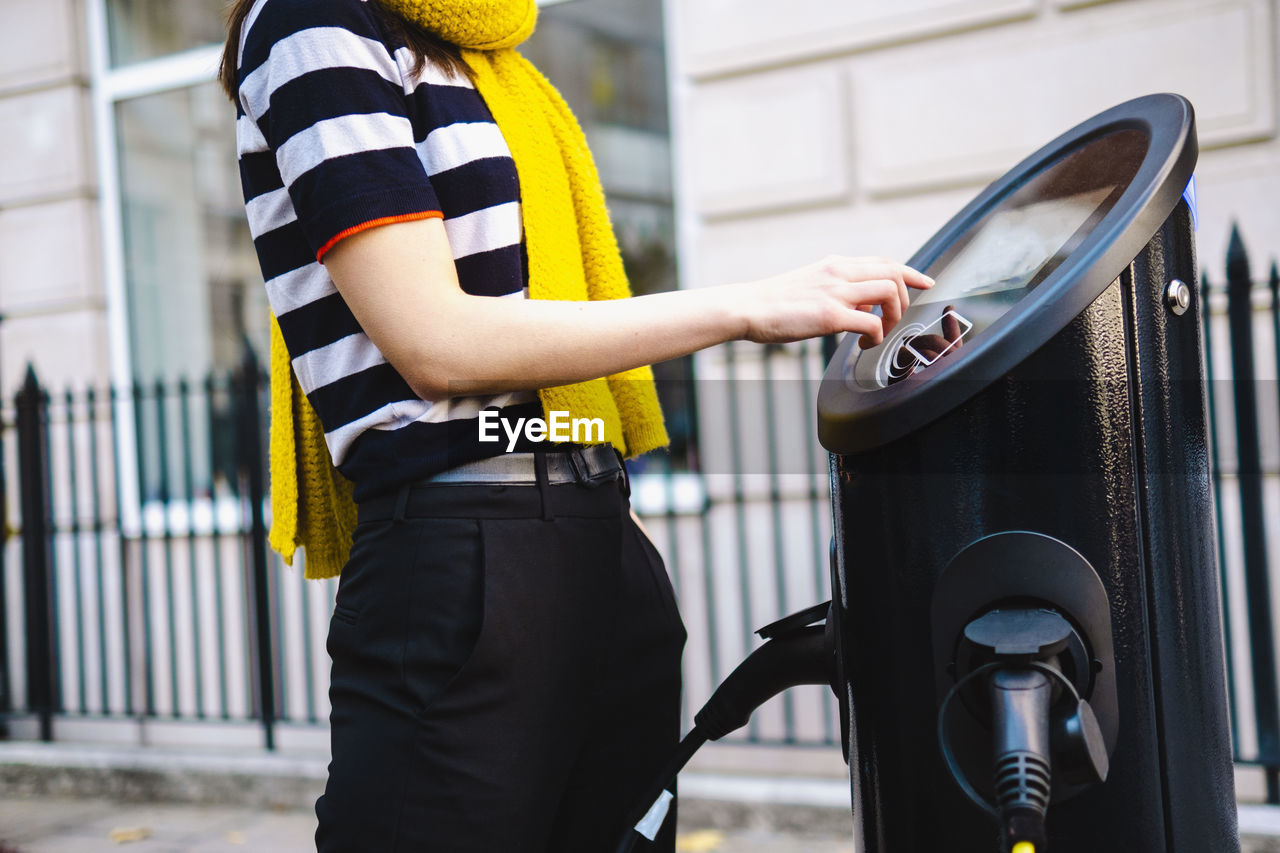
0, 742, 1280, 853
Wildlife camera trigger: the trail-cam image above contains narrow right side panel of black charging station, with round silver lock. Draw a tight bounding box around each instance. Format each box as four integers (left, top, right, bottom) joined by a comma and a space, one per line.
1128, 205, 1239, 853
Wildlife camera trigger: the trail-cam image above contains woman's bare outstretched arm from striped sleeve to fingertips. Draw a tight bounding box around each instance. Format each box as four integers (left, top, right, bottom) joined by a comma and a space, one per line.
324, 213, 933, 400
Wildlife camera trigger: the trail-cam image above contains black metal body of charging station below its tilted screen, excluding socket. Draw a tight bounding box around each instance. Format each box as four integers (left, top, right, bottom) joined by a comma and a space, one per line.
833, 205, 1238, 853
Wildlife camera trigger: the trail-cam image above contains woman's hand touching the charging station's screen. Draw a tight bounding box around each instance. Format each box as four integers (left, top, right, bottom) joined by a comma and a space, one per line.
724, 255, 933, 347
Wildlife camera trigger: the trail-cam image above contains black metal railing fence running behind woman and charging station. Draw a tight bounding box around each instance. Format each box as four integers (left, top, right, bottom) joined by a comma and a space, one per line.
0, 225, 1280, 778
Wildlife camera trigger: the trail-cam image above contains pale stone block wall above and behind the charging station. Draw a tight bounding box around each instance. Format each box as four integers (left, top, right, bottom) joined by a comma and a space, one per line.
669, 0, 1280, 287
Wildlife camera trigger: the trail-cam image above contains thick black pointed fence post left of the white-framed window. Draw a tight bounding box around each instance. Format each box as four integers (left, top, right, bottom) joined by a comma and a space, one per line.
15, 365, 59, 740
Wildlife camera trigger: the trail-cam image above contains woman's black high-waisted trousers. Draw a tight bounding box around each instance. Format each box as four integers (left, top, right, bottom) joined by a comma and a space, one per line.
316, 468, 685, 853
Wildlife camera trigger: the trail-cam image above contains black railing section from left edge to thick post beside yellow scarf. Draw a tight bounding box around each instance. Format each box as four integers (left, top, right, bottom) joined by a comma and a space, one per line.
0, 353, 285, 748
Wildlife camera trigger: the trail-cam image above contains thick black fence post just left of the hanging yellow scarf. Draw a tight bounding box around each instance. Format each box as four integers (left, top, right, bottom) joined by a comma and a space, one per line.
236, 345, 275, 749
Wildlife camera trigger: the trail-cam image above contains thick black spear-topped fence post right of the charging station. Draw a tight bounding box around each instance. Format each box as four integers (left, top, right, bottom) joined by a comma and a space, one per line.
1226, 227, 1280, 804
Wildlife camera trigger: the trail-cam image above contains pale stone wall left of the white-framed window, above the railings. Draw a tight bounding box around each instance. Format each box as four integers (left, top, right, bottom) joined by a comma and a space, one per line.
0, 0, 108, 393
